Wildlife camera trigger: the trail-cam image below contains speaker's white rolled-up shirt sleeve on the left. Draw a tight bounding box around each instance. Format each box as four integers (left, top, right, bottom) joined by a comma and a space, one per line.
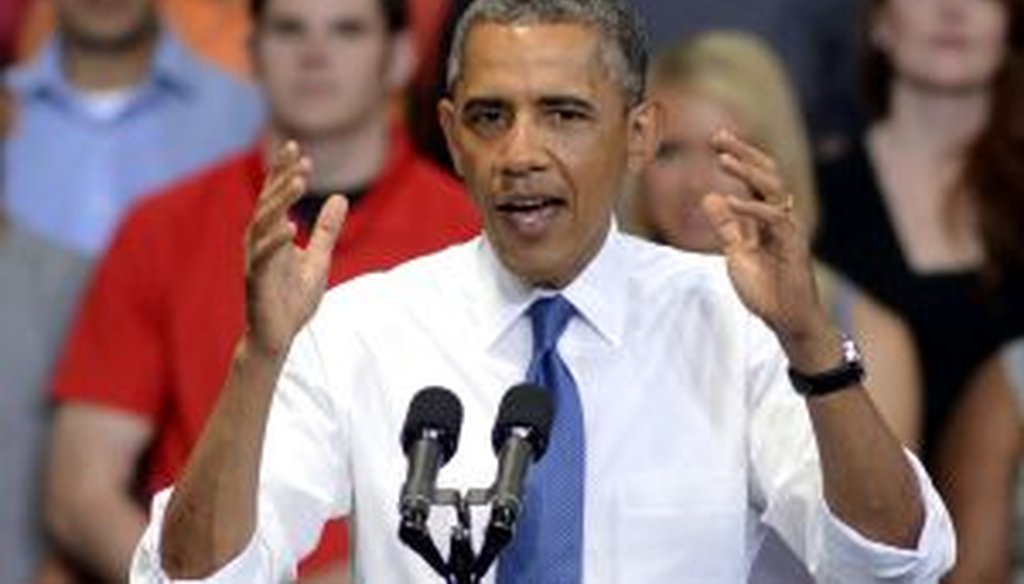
130, 309, 358, 584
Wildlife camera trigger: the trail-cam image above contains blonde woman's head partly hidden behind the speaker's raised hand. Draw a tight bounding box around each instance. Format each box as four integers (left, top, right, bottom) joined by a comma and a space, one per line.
623, 33, 816, 252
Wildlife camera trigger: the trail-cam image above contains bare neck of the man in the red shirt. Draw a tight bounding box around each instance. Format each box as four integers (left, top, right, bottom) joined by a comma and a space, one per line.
266, 116, 389, 191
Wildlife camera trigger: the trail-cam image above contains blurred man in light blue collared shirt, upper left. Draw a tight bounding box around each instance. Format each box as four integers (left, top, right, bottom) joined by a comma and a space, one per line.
4, 0, 263, 256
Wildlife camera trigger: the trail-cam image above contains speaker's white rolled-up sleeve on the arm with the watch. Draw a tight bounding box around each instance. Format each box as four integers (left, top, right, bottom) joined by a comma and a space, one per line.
750, 315, 956, 584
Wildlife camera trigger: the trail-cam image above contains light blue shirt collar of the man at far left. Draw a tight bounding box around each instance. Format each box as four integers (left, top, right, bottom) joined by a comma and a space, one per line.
10, 29, 195, 97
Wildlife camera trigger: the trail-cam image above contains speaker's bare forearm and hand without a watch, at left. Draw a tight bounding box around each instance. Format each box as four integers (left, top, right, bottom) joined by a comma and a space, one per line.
160, 143, 346, 578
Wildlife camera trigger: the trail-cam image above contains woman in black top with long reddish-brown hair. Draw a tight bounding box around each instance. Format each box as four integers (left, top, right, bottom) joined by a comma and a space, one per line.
816, 0, 1024, 582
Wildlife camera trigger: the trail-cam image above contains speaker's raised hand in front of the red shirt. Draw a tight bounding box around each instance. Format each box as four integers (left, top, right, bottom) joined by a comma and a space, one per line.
246, 141, 348, 356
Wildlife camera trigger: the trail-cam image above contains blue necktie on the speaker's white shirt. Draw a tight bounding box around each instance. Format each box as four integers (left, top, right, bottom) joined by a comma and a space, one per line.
498, 296, 586, 584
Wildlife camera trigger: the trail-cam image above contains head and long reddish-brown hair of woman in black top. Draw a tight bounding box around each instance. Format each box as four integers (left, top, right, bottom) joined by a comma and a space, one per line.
862, 0, 1024, 276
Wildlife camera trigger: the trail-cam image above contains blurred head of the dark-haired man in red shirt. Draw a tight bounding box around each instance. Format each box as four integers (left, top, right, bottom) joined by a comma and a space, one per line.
251, 0, 416, 139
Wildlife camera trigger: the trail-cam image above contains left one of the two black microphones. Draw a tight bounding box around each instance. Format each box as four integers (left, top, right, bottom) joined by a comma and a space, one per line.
398, 387, 462, 575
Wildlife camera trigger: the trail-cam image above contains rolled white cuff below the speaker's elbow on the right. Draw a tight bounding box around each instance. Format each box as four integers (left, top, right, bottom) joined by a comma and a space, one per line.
823, 451, 956, 583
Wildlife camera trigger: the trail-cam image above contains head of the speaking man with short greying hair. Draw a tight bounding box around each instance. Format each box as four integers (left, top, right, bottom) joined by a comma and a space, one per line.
440, 0, 653, 288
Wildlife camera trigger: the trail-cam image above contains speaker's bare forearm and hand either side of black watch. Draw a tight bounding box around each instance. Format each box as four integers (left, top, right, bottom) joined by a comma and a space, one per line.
703, 132, 925, 548
